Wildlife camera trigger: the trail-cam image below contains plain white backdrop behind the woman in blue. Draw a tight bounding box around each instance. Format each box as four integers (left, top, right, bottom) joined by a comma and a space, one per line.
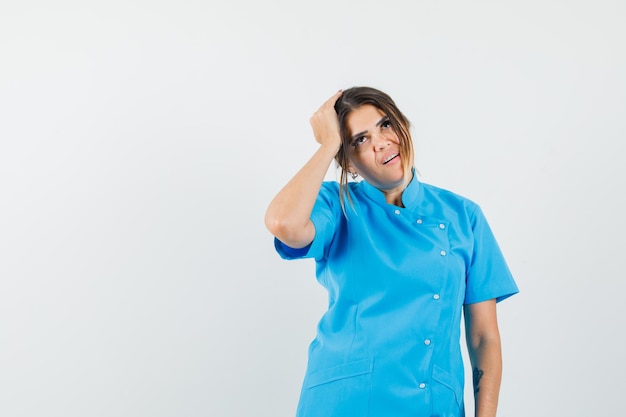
0, 0, 626, 417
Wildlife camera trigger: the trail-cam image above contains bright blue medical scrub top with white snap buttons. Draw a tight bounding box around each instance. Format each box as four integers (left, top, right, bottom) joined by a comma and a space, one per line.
275, 176, 518, 417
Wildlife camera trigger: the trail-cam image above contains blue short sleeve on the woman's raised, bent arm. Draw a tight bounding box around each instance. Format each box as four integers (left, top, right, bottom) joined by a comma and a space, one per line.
274, 181, 343, 260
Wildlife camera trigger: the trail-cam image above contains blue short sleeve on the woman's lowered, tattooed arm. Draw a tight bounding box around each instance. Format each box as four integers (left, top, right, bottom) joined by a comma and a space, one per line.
464, 206, 519, 304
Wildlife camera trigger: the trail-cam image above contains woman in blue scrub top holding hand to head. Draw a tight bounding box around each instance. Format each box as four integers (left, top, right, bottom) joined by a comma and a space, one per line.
265, 87, 518, 417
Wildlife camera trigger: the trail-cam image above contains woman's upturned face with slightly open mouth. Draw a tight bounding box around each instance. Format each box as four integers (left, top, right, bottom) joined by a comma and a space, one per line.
346, 104, 404, 193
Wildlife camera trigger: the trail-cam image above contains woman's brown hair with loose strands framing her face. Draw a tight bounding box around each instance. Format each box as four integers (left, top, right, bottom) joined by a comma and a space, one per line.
335, 87, 413, 212
